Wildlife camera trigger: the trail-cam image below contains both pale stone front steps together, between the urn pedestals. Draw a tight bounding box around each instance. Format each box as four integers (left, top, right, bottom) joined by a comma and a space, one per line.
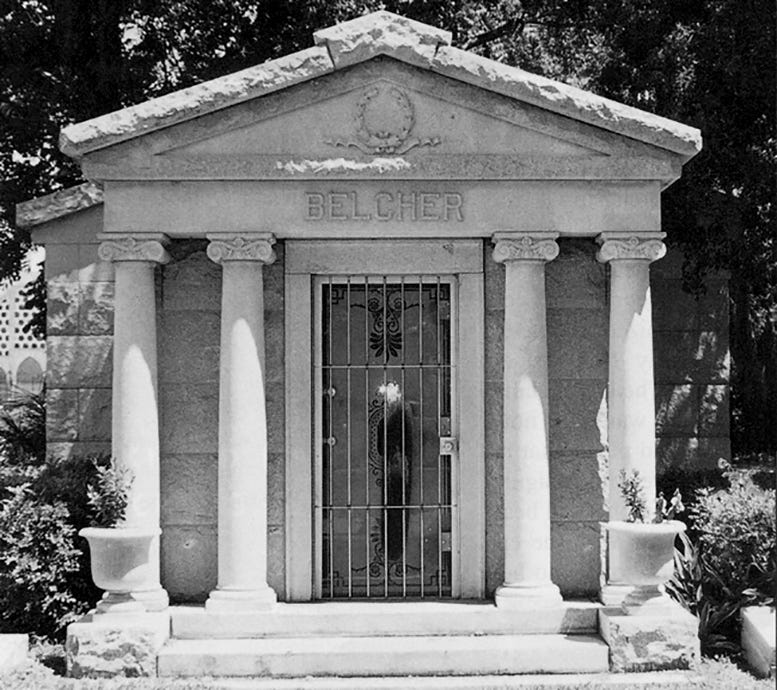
157, 602, 608, 678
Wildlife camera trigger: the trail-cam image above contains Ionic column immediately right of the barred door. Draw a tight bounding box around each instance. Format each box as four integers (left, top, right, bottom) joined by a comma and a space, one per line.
494, 233, 561, 608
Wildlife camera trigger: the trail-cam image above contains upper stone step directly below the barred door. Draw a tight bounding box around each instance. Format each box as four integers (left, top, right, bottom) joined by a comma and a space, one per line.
171, 601, 600, 639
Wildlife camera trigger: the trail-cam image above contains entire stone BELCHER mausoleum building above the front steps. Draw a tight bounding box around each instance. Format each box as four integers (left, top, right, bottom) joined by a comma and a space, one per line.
19, 12, 729, 676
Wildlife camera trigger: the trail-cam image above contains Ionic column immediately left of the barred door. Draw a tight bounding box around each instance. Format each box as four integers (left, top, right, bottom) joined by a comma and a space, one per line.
206, 233, 276, 611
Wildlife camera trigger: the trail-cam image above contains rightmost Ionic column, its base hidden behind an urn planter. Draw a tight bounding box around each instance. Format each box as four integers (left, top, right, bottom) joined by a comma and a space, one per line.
597, 233, 666, 520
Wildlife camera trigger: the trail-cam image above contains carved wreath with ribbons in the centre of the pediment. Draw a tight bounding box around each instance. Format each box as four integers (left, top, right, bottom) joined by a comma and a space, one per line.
326, 84, 440, 156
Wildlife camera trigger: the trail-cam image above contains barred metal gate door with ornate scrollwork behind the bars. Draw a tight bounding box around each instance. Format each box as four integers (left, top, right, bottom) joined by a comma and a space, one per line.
314, 276, 457, 598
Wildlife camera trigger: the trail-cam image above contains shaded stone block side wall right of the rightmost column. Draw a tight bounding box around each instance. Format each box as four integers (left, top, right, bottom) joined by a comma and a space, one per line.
651, 250, 731, 474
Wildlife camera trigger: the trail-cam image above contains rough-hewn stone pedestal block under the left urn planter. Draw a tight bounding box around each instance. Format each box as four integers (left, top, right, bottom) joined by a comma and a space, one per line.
65, 613, 170, 678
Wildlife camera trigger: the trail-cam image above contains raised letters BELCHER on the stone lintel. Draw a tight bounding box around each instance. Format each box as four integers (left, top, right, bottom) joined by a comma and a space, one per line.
305, 192, 464, 222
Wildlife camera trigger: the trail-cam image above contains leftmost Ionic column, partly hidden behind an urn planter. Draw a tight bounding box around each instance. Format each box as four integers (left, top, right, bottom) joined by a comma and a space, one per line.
98, 233, 170, 611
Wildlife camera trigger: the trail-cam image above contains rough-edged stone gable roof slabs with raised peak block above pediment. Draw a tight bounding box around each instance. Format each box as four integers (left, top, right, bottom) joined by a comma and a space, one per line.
60, 11, 701, 161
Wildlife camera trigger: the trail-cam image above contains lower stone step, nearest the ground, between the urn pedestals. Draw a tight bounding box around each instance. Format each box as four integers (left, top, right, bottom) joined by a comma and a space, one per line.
157, 635, 608, 678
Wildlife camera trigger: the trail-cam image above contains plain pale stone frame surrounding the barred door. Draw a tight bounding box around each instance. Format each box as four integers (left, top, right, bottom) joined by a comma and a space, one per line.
285, 240, 486, 601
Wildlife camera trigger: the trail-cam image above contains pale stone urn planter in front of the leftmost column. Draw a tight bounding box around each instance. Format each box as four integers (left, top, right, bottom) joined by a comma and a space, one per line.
78, 527, 161, 613
